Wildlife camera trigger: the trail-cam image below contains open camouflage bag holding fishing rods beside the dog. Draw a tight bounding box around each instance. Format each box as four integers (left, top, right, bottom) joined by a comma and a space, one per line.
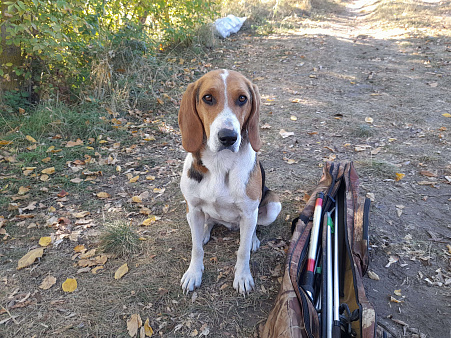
259, 162, 376, 338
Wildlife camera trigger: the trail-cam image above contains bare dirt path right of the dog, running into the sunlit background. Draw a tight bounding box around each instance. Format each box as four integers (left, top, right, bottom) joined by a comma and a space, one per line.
213, 1, 451, 337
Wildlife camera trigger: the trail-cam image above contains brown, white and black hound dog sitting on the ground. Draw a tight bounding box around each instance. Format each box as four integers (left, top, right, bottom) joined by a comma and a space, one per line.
178, 70, 281, 294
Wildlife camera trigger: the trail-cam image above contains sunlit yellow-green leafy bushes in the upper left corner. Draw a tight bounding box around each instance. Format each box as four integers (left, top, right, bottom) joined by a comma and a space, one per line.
0, 0, 216, 100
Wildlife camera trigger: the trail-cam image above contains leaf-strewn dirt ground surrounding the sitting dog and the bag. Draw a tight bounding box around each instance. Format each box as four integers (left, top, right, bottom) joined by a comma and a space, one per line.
0, 2, 451, 338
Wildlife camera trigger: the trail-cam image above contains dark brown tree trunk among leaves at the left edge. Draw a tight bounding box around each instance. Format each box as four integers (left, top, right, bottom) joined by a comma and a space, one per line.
0, 3, 24, 91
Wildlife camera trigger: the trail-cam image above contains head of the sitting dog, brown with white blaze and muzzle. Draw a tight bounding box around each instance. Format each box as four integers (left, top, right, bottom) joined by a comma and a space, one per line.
179, 70, 261, 153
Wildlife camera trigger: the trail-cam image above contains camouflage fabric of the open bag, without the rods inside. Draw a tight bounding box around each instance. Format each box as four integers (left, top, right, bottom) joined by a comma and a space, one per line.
259, 162, 376, 338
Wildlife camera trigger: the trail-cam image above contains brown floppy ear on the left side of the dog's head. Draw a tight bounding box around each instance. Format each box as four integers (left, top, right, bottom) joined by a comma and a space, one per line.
179, 82, 204, 153
